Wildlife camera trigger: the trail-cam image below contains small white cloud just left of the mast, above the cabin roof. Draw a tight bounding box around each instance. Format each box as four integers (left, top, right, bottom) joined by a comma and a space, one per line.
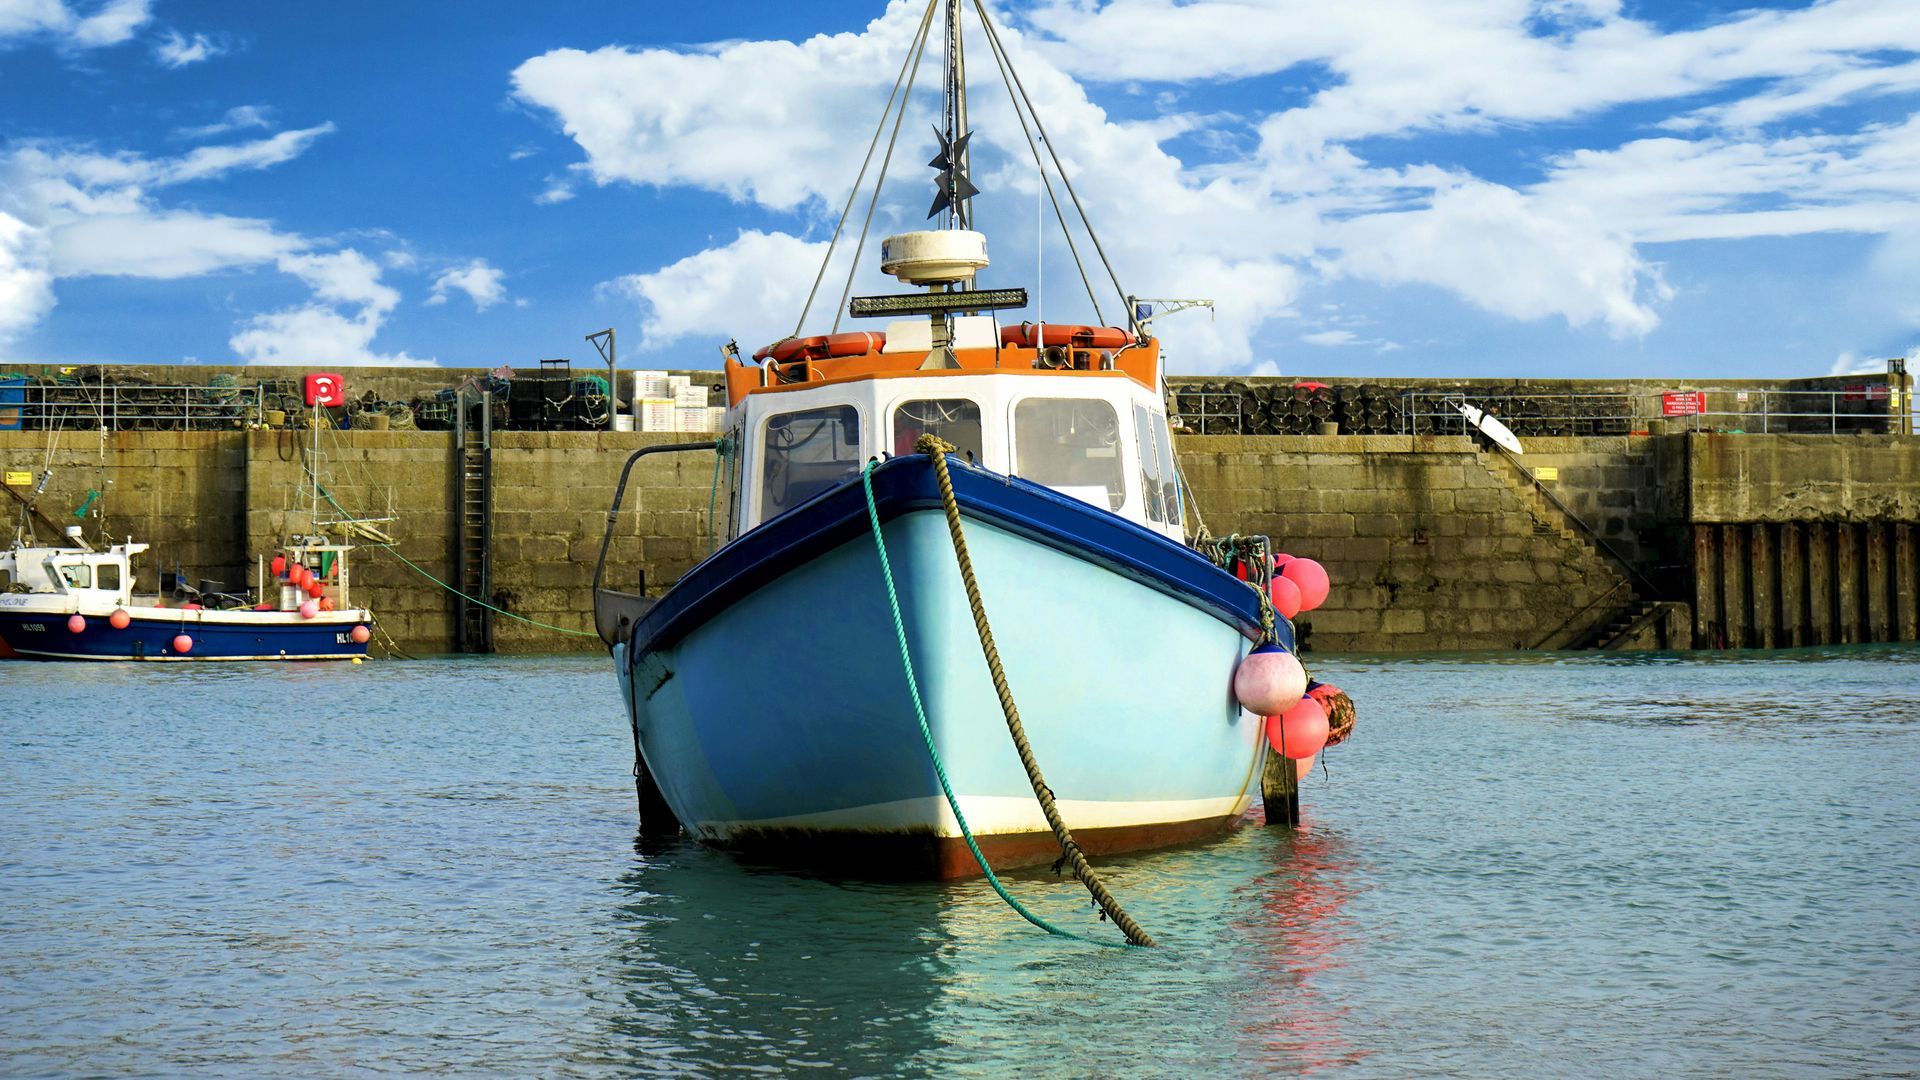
603, 229, 831, 352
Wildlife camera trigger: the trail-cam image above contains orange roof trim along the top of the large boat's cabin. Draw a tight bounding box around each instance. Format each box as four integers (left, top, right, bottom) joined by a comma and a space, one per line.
726, 338, 1160, 407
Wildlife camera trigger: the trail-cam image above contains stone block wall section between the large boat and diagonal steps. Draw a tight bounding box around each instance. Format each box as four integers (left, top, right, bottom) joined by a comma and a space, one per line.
1179, 436, 1626, 651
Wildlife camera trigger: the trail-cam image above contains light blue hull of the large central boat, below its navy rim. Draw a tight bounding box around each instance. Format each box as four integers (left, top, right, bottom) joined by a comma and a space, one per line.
616, 509, 1261, 872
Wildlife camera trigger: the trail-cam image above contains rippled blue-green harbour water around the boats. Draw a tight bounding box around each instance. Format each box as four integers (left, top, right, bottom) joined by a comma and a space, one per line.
0, 646, 1920, 1076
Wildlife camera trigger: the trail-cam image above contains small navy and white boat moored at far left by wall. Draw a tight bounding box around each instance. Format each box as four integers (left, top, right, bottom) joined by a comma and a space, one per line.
0, 538, 372, 661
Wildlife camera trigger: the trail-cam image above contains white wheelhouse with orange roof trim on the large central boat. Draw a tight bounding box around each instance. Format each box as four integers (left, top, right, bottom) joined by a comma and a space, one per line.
728, 315, 1185, 540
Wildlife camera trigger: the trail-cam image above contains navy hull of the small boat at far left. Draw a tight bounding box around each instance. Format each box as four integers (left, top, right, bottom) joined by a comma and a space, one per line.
0, 594, 371, 663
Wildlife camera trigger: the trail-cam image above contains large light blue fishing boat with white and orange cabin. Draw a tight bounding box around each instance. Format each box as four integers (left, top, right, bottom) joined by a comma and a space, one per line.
595, 2, 1304, 876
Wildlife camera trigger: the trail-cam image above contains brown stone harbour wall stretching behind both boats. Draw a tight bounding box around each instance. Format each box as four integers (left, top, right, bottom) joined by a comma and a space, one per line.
0, 430, 1920, 651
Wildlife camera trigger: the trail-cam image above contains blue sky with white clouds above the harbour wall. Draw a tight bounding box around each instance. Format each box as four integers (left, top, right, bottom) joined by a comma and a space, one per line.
0, 0, 1920, 377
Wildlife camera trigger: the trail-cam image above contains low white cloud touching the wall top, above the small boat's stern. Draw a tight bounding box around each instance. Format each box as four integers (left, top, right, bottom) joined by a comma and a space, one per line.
228, 248, 432, 367
